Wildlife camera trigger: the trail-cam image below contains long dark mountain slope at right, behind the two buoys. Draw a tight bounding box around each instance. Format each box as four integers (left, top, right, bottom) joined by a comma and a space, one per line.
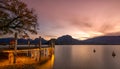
84, 36, 120, 45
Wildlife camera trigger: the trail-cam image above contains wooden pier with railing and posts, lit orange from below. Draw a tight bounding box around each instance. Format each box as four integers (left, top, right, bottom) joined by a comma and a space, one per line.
0, 33, 55, 64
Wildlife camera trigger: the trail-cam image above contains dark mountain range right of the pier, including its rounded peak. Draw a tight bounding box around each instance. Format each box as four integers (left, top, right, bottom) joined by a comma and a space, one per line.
56, 35, 120, 45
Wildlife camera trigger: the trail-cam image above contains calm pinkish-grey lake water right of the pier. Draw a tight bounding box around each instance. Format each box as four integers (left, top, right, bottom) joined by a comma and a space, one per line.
53, 45, 120, 69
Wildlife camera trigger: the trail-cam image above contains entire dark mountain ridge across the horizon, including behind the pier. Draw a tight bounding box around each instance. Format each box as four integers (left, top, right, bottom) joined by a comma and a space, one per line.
0, 35, 120, 45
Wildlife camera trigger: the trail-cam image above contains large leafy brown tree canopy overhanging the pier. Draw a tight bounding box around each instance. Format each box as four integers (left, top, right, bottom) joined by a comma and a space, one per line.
0, 0, 37, 34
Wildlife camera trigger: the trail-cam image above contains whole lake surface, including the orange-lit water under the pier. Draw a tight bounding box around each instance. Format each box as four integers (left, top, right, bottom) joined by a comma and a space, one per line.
0, 45, 120, 69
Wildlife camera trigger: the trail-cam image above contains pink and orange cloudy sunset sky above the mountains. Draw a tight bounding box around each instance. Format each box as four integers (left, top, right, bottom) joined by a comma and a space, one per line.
23, 0, 120, 40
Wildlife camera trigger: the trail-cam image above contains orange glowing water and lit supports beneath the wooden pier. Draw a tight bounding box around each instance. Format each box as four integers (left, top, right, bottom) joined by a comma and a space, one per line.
0, 48, 54, 69
